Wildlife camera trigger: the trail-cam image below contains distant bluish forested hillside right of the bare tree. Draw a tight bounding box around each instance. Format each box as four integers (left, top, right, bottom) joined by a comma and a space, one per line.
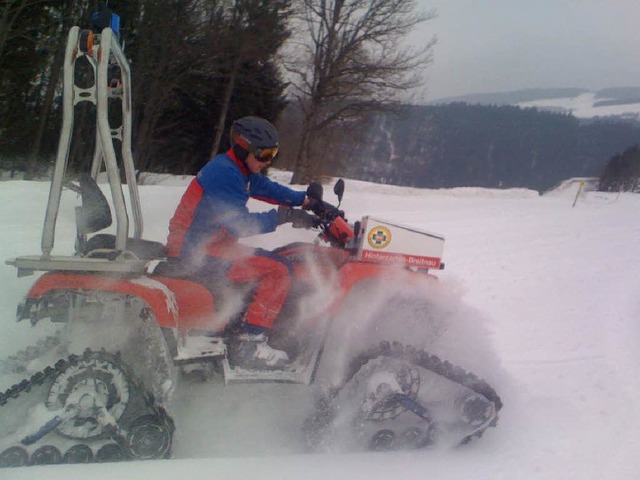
330, 103, 640, 191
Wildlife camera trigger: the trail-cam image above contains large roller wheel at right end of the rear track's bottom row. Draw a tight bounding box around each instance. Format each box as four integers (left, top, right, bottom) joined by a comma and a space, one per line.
127, 415, 173, 460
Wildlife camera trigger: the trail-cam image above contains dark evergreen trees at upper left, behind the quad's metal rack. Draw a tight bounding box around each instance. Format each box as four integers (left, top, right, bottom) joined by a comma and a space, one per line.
0, 0, 292, 174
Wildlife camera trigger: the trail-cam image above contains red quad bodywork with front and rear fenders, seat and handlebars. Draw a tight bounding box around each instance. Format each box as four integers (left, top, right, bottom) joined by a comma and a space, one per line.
16, 177, 444, 383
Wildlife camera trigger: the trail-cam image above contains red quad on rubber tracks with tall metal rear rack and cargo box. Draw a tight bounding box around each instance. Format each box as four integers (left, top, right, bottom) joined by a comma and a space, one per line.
0, 15, 502, 466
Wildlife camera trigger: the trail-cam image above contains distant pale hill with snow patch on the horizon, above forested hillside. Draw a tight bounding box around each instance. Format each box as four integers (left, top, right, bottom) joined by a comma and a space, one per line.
431, 87, 640, 121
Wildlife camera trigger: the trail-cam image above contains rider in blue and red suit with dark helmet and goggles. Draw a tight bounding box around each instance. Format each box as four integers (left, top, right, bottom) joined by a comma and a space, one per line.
167, 116, 313, 368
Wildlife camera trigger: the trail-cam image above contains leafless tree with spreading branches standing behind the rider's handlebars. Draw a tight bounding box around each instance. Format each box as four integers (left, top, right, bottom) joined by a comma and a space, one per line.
287, 0, 435, 183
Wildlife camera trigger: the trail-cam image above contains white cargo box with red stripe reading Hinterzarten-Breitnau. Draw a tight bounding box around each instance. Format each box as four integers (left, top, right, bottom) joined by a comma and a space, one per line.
357, 216, 444, 269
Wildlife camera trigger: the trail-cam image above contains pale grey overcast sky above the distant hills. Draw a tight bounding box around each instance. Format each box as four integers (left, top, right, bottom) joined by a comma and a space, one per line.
413, 0, 640, 100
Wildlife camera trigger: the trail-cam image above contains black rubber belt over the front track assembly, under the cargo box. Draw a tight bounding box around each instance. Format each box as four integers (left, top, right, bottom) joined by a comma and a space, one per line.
331, 342, 503, 443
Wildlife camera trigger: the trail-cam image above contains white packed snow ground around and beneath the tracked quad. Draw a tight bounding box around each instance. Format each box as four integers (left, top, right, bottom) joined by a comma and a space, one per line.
0, 173, 640, 480
